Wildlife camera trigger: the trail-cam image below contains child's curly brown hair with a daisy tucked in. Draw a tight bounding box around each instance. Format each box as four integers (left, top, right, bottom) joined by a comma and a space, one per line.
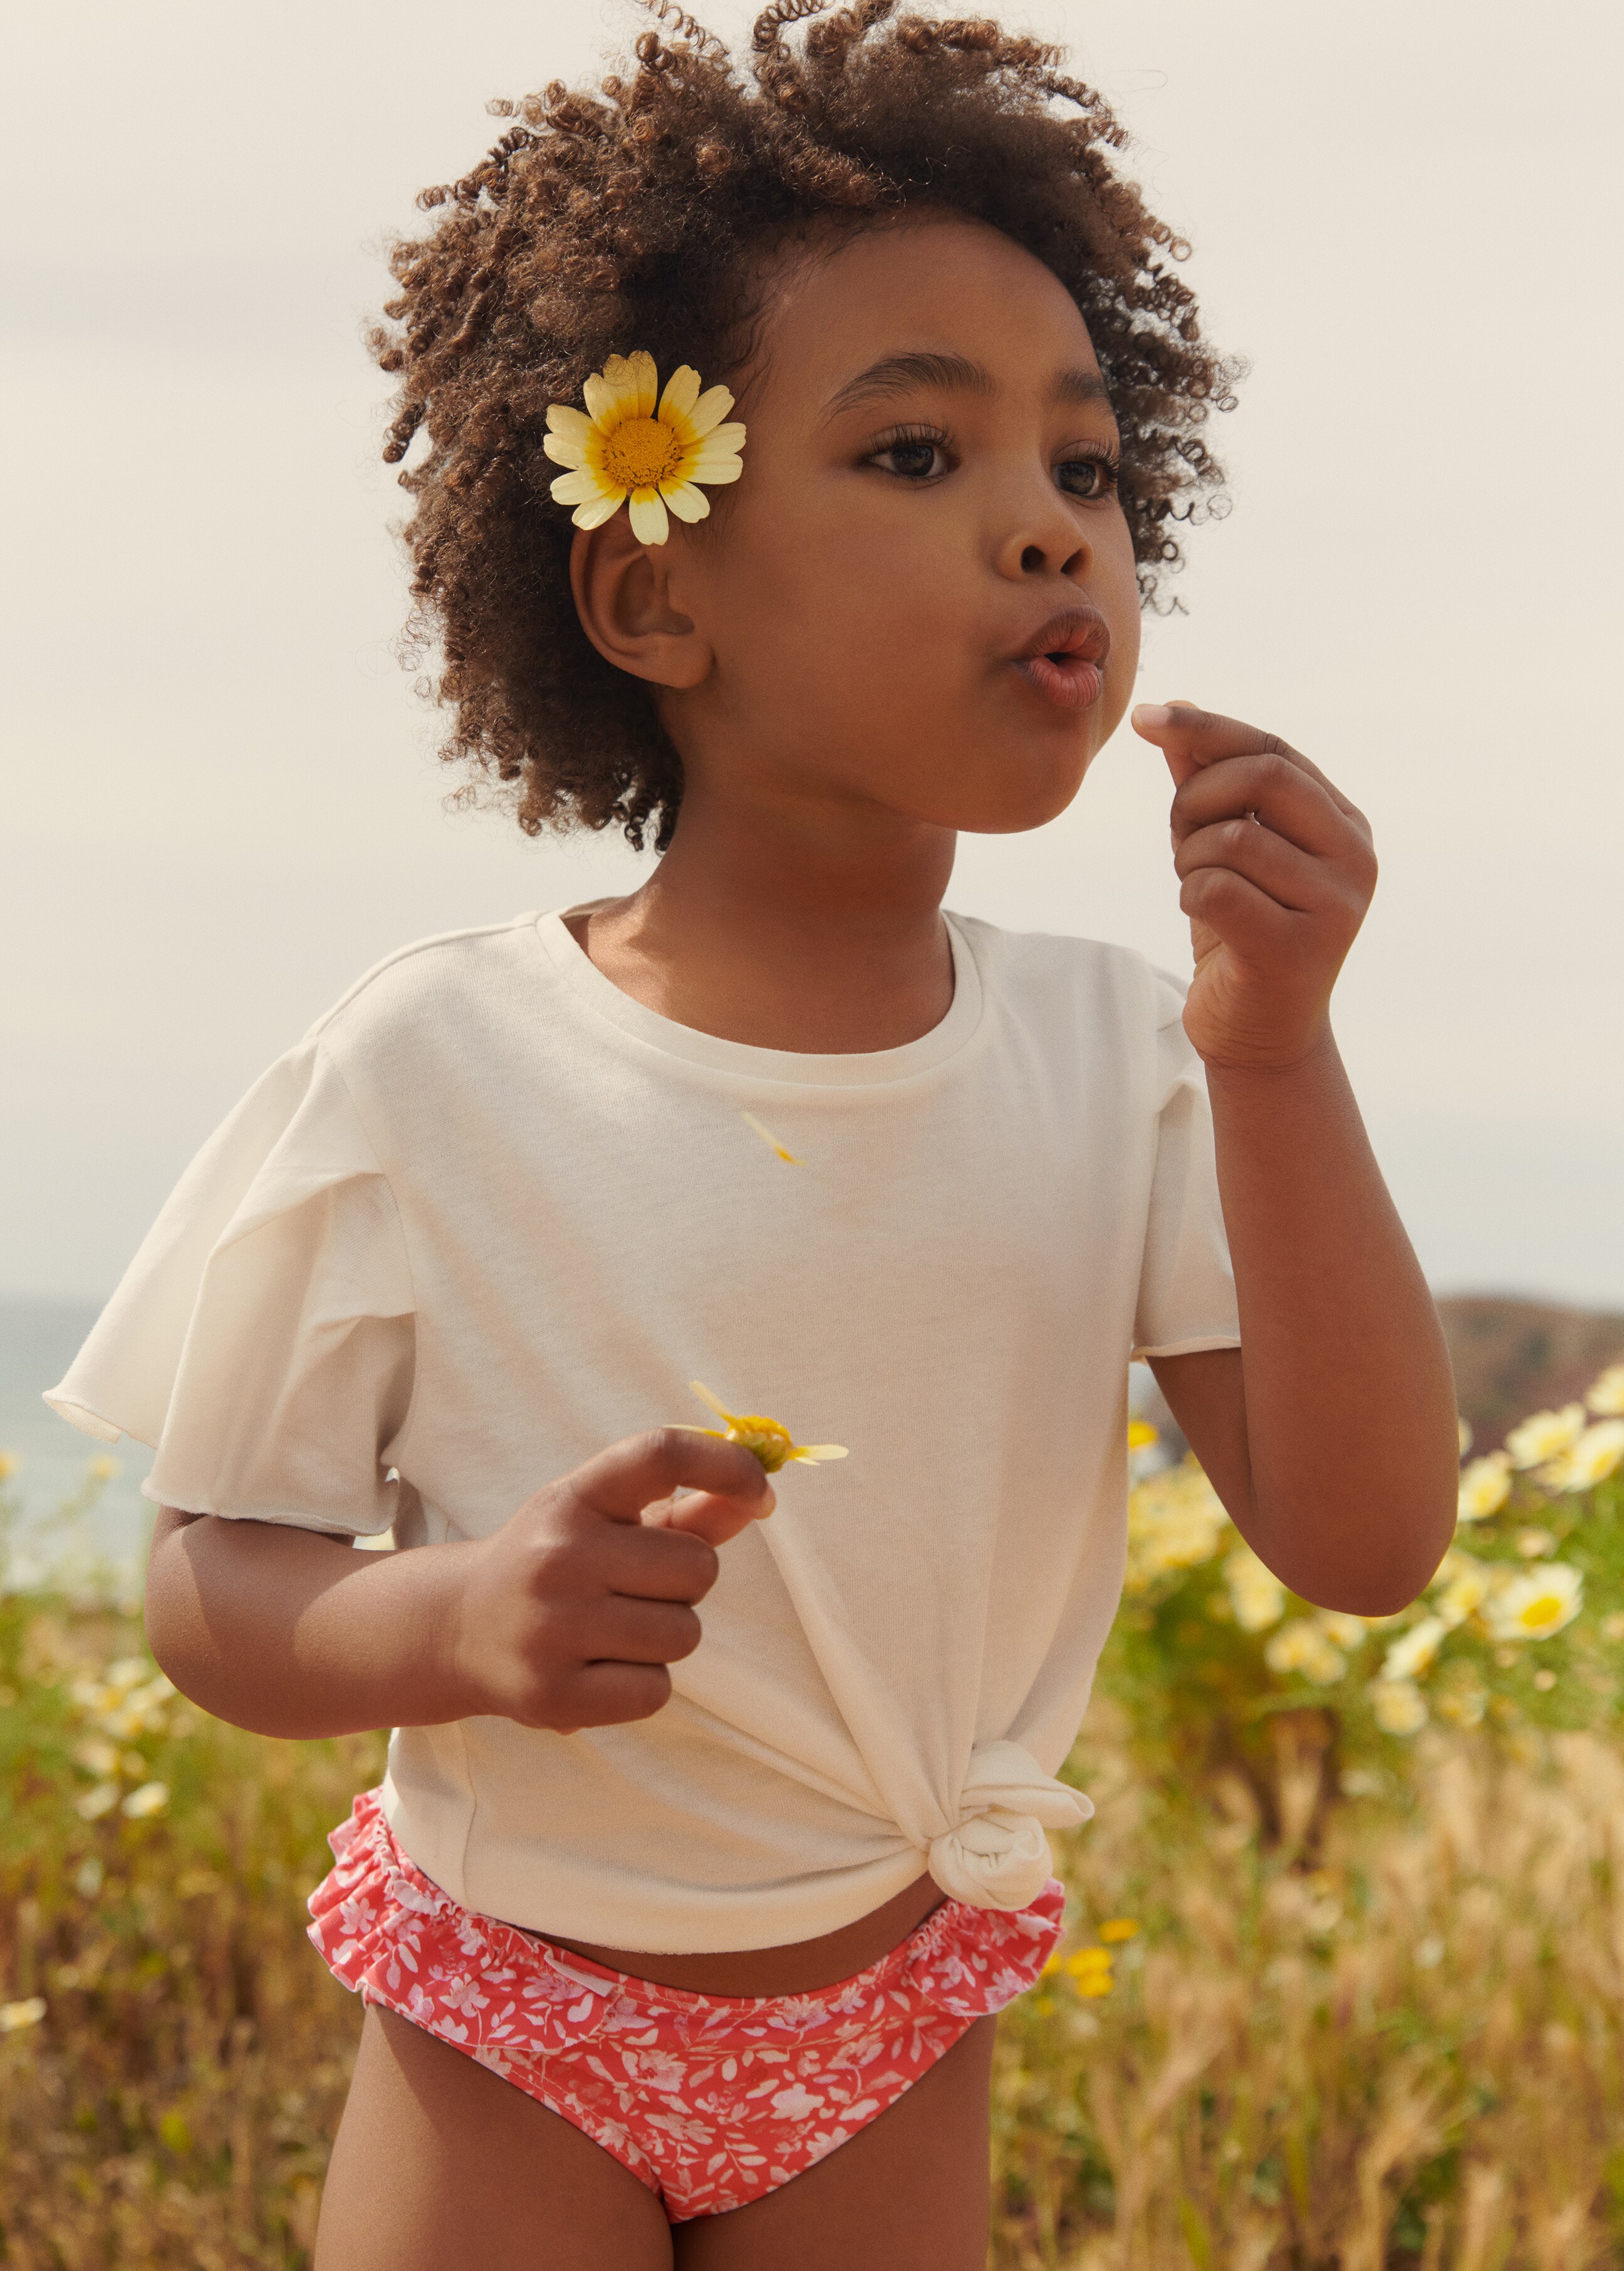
370, 0, 1240, 850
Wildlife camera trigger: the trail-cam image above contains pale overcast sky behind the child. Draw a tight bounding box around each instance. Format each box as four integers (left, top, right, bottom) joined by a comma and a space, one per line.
0, 0, 1624, 1306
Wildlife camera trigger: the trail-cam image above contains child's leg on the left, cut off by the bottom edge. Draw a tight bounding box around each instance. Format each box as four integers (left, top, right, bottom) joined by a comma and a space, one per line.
316, 2005, 672, 2271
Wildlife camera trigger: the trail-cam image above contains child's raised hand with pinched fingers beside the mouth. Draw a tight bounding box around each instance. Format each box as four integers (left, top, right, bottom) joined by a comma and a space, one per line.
1133, 702, 1377, 1069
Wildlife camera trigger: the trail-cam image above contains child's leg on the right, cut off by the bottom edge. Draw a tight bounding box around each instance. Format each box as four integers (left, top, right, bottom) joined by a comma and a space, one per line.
672, 2019, 997, 2271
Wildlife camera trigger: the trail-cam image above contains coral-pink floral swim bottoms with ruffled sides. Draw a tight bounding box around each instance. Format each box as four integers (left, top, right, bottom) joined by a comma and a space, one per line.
309, 1790, 1063, 2223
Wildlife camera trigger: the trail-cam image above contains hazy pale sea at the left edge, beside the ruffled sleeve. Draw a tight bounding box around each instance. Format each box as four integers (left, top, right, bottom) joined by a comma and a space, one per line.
0, 1299, 152, 1588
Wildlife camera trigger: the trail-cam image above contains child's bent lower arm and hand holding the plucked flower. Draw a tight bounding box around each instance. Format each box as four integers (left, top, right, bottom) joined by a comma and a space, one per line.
145, 1428, 774, 1737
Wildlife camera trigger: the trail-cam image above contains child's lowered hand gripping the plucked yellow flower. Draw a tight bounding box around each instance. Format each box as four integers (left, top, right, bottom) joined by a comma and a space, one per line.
450, 1427, 774, 1735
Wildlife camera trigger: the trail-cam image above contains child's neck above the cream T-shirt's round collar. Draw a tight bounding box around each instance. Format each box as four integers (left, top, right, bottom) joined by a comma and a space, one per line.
570, 793, 954, 1056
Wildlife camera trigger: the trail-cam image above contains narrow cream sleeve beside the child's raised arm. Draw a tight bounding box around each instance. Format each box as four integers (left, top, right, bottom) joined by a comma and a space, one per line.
1133, 970, 1240, 1356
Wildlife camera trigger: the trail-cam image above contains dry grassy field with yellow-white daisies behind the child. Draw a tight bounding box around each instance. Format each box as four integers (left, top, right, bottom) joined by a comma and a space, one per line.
0, 1374, 1624, 2271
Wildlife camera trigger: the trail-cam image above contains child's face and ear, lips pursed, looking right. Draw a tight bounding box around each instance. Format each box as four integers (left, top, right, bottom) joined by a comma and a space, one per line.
577, 216, 1140, 833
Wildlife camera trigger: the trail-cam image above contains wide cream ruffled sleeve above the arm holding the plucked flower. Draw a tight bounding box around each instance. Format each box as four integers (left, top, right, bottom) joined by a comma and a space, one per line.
46, 1040, 415, 1536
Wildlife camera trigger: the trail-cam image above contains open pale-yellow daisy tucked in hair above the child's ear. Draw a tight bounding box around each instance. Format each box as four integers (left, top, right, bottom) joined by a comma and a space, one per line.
543, 348, 745, 545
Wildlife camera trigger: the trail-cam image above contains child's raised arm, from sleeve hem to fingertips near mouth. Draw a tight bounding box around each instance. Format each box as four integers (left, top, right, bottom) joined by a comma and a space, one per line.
1133, 702, 1458, 1617
